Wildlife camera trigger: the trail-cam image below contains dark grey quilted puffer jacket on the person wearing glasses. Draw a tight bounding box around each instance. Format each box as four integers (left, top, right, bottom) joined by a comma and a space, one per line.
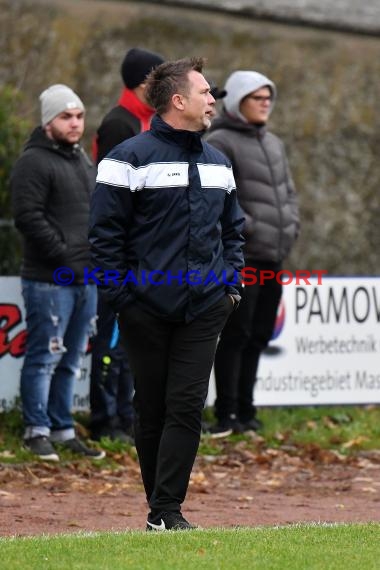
206, 113, 299, 262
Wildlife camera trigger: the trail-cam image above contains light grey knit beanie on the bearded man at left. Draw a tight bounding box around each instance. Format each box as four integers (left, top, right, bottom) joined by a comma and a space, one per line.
40, 83, 84, 127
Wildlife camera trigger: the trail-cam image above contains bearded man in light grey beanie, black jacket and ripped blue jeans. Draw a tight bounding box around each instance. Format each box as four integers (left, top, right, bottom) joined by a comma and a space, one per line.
11, 84, 104, 461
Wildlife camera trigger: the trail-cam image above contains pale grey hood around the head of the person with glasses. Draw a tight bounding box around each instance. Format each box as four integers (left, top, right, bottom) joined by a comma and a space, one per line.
223, 71, 277, 123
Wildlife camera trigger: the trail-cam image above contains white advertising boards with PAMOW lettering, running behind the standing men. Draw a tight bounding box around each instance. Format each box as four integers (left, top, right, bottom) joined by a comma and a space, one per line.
0, 277, 380, 411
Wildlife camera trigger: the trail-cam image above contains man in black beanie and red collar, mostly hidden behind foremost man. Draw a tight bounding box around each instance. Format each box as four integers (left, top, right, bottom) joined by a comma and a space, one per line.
90, 47, 164, 443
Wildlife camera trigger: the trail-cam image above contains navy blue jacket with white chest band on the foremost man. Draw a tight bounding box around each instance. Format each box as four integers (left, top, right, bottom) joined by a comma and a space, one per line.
89, 115, 244, 322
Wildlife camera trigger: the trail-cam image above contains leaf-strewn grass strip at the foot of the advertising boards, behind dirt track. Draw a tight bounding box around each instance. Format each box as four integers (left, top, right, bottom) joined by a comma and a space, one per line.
0, 405, 380, 462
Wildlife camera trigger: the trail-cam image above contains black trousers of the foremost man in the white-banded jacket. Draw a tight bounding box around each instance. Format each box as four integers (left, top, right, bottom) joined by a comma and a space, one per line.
119, 295, 233, 515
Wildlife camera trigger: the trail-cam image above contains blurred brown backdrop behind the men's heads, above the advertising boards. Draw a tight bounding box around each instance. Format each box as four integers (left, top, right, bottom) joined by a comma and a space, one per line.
0, 0, 380, 275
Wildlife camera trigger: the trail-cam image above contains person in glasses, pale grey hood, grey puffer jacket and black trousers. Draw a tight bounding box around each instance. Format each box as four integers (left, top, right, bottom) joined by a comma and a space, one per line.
206, 70, 299, 436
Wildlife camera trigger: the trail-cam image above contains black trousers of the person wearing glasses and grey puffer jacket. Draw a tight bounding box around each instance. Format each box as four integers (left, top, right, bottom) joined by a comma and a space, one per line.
214, 261, 282, 423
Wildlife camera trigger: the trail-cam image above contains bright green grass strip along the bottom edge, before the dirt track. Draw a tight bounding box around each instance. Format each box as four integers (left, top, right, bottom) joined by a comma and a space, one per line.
0, 523, 380, 570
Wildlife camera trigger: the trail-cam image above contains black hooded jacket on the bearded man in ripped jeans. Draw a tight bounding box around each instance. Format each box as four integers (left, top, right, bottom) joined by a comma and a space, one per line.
11, 127, 96, 283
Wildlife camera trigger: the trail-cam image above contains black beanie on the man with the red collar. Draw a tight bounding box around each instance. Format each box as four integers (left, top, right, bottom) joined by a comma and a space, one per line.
121, 48, 164, 89
